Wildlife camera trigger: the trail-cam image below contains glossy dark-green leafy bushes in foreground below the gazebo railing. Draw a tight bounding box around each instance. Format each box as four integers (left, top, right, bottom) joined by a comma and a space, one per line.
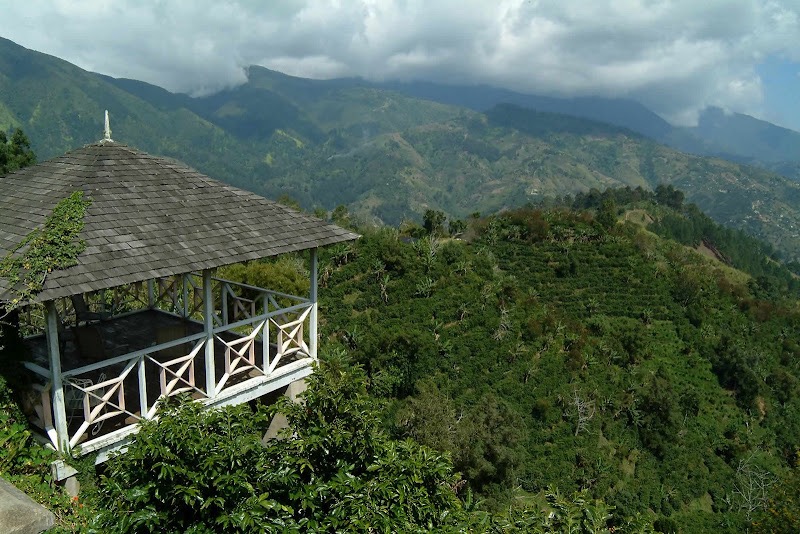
96, 359, 468, 532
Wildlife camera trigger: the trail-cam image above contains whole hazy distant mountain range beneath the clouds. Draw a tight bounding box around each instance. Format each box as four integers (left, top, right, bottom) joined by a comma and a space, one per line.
0, 34, 800, 258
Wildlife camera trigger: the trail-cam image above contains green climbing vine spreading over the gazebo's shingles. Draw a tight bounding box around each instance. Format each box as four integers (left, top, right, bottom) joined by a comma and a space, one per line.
0, 191, 92, 311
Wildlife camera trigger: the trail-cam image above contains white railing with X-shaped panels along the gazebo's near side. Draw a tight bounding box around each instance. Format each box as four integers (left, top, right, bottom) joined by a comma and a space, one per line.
26, 303, 312, 454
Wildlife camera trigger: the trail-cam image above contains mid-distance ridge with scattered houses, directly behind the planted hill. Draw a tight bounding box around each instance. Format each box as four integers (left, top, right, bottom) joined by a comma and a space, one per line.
255, 106, 800, 257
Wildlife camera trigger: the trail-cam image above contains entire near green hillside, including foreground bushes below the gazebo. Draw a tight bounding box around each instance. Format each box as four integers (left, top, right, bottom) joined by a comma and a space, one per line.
0, 191, 800, 533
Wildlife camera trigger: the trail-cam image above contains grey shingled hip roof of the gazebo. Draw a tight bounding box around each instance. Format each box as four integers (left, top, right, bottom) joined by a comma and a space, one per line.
0, 141, 358, 301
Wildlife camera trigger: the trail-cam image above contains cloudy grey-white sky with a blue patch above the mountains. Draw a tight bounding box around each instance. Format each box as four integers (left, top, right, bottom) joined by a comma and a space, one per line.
0, 0, 800, 130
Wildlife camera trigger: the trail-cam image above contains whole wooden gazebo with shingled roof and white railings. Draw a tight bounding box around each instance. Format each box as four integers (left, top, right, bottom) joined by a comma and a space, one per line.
0, 124, 358, 468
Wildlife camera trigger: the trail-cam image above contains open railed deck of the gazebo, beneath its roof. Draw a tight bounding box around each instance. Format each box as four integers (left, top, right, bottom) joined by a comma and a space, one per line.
17, 274, 316, 462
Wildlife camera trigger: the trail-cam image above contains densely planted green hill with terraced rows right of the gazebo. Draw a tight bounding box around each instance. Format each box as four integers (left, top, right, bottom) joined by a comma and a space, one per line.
296, 199, 800, 532
